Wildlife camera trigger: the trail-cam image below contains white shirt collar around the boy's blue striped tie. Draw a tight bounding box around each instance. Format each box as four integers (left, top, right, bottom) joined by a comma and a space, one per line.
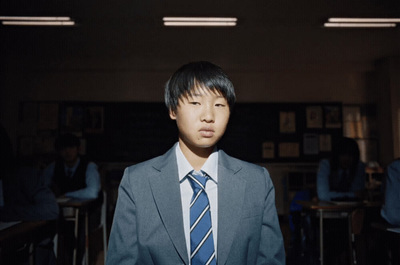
175, 142, 218, 183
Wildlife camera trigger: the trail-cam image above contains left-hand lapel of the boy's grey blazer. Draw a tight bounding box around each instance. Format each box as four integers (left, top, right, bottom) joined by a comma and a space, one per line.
150, 148, 189, 264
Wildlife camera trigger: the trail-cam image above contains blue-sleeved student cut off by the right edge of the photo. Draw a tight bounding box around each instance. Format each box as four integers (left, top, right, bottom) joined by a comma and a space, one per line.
381, 158, 400, 227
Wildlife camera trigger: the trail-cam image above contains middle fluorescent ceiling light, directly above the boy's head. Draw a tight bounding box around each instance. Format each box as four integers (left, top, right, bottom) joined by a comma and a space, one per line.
163, 17, 237, 27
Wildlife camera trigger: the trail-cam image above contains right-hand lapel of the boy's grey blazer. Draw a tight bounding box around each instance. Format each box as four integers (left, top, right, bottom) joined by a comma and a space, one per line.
217, 151, 246, 265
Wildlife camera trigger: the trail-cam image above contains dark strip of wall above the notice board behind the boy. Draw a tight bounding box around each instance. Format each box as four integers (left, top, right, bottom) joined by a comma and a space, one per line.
0, 69, 374, 144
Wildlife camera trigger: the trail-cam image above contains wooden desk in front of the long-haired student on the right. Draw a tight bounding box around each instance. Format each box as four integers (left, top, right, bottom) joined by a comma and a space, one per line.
296, 201, 365, 265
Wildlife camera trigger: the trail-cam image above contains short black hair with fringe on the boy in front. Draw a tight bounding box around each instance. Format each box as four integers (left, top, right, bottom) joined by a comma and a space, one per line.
164, 61, 236, 111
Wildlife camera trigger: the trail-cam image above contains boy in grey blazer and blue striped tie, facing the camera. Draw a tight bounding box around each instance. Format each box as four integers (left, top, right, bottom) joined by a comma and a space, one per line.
107, 62, 285, 265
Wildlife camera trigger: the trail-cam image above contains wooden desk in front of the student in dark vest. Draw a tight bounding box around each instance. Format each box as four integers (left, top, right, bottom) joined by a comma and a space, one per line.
57, 198, 98, 265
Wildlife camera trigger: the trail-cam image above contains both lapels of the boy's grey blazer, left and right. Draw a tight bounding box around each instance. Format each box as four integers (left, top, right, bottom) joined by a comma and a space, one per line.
150, 147, 246, 265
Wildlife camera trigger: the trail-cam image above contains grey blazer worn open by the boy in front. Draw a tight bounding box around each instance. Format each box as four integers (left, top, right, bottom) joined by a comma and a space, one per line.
107, 145, 285, 265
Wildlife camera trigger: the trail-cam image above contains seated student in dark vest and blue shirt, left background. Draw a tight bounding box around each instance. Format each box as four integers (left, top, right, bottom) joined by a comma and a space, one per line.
43, 134, 101, 199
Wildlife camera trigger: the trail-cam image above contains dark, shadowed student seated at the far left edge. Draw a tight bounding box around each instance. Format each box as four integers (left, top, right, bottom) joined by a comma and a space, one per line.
0, 126, 59, 265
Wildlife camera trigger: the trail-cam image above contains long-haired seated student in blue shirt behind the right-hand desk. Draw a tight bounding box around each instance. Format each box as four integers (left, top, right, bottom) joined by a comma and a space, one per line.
317, 137, 366, 265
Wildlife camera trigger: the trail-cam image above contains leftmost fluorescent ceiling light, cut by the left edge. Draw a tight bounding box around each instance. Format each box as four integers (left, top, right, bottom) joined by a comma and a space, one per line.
0, 16, 75, 26
